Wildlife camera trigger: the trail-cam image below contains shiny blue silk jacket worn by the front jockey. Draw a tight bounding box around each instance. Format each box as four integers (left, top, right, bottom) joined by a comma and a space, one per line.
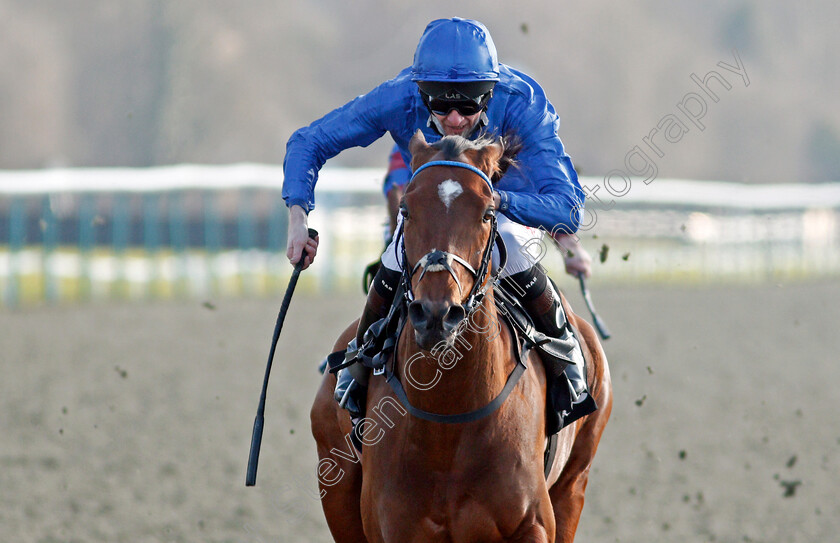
283, 64, 584, 232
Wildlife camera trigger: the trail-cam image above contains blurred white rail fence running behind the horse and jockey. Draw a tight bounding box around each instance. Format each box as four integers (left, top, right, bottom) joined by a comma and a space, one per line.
0, 164, 840, 305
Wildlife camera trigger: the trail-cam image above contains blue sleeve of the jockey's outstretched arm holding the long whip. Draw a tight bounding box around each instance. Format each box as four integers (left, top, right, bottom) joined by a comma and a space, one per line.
283, 82, 406, 213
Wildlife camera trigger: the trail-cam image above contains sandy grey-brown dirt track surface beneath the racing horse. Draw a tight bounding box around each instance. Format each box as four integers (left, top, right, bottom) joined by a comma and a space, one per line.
0, 282, 840, 543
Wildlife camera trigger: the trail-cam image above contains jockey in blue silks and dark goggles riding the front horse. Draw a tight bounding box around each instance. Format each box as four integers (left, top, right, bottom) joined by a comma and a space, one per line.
283, 17, 596, 432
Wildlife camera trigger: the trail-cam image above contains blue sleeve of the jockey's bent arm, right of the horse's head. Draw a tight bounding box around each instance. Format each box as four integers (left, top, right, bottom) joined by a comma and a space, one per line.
499, 80, 584, 233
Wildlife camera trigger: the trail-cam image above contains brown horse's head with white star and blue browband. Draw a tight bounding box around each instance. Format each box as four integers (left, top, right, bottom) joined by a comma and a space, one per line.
400, 131, 503, 349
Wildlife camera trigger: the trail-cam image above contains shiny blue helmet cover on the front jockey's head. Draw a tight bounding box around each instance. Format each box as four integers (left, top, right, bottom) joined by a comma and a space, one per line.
411, 17, 499, 83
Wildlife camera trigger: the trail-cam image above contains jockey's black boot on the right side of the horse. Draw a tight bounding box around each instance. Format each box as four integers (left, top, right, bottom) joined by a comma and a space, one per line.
509, 264, 597, 435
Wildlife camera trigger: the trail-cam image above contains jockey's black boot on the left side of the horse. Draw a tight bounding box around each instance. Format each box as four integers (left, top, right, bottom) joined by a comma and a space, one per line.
335, 266, 400, 419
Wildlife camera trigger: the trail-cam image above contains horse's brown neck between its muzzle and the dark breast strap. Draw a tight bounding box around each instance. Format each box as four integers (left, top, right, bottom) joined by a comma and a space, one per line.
400, 292, 514, 414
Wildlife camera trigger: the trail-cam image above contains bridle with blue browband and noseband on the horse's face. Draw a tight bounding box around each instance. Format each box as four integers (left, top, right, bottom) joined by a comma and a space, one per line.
397, 160, 507, 313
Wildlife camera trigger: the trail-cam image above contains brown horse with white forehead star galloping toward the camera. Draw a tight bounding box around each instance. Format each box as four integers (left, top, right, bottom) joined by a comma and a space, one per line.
311, 132, 612, 543
